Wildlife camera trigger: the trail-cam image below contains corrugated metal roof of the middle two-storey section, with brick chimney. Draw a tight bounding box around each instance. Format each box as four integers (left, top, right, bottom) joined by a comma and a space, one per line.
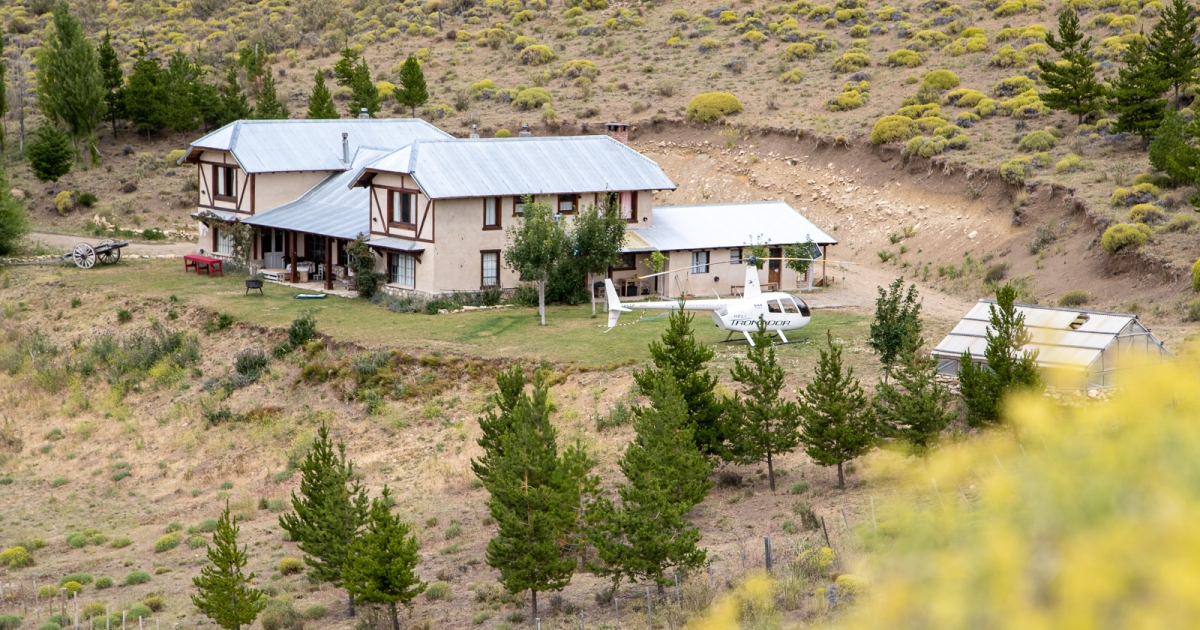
354, 136, 676, 199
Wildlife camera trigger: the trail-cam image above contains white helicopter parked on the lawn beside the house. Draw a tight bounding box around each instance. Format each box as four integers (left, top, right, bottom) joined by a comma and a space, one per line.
604, 257, 812, 346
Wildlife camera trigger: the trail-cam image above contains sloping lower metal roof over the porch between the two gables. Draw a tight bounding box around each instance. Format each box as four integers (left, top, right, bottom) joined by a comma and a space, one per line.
244, 148, 390, 239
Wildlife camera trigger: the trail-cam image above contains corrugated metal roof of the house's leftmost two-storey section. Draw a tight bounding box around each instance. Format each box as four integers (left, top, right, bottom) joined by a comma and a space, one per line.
180, 118, 451, 173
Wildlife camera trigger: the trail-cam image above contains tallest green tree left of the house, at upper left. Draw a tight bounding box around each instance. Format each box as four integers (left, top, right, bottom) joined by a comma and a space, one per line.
37, 1, 104, 158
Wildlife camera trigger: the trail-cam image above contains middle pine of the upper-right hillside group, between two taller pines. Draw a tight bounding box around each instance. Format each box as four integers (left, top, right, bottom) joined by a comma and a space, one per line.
1109, 38, 1168, 146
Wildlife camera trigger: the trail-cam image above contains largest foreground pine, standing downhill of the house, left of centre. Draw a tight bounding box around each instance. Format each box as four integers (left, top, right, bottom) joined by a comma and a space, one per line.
480, 364, 575, 617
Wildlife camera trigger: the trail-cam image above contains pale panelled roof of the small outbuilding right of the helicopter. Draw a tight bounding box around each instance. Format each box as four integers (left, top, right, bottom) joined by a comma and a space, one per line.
932, 300, 1170, 370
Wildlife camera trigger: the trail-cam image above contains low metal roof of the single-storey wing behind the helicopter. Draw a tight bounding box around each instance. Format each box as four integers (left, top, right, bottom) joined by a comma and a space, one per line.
625, 202, 838, 251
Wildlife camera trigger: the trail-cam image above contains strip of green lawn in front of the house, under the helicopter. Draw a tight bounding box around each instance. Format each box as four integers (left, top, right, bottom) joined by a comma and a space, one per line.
49, 259, 866, 366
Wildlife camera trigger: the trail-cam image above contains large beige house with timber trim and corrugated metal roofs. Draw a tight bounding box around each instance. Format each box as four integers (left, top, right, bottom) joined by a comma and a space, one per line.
181, 119, 836, 296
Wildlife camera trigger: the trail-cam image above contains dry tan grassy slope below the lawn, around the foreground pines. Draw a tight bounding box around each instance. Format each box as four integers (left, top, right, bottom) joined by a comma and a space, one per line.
0, 269, 907, 628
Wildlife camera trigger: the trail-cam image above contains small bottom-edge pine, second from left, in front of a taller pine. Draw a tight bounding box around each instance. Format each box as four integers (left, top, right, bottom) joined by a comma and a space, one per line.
342, 486, 425, 630
